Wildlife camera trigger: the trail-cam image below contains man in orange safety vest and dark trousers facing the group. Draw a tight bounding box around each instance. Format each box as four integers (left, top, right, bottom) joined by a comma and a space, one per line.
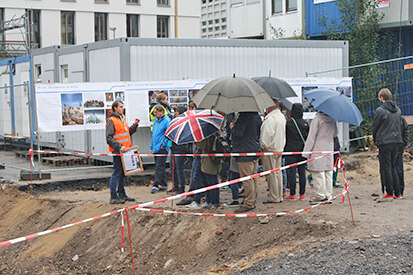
106, 100, 139, 204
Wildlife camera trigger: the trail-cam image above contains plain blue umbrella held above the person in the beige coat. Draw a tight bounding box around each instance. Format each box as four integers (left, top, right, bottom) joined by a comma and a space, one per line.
304, 88, 363, 126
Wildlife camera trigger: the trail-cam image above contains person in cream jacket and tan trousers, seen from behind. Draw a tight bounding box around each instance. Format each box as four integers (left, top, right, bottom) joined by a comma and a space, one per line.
260, 99, 286, 204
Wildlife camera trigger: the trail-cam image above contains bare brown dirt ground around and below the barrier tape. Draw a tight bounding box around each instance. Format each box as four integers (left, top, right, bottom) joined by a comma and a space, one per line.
0, 152, 413, 274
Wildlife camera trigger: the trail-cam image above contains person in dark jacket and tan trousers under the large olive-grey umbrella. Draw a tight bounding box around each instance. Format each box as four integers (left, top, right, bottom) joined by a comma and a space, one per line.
230, 112, 262, 213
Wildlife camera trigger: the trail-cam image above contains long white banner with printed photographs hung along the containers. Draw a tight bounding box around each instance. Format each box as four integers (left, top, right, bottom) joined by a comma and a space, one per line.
36, 77, 352, 132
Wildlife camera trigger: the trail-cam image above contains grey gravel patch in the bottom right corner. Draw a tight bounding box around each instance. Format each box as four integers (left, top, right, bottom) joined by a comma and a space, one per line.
232, 233, 413, 275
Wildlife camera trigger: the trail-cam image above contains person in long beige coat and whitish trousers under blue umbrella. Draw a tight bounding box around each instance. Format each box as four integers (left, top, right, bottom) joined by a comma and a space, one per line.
303, 111, 338, 204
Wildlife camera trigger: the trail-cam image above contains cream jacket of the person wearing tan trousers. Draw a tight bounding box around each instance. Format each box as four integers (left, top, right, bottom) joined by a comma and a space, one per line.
260, 109, 286, 152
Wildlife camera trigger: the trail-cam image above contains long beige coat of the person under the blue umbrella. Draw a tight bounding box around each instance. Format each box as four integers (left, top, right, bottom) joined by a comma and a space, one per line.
303, 113, 338, 171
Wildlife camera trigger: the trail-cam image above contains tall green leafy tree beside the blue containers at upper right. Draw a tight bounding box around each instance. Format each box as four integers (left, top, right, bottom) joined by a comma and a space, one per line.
318, 0, 385, 132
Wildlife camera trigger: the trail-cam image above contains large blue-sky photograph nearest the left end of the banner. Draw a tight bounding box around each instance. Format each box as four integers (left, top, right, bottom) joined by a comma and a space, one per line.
61, 93, 84, 126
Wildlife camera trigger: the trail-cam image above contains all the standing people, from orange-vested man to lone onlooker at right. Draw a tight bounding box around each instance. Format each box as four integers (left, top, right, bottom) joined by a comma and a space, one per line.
106, 89, 408, 209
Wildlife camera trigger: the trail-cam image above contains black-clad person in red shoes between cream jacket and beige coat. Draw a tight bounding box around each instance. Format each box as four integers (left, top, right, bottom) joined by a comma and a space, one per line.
284, 103, 310, 201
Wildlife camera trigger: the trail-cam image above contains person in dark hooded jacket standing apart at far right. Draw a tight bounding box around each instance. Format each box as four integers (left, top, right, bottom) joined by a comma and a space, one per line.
372, 88, 403, 200
